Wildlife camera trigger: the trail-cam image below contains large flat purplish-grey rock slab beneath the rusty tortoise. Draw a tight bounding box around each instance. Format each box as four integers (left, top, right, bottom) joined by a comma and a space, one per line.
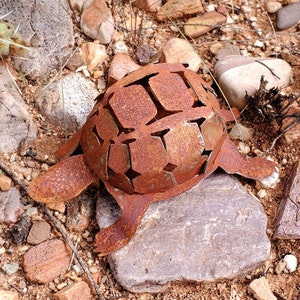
97, 173, 270, 292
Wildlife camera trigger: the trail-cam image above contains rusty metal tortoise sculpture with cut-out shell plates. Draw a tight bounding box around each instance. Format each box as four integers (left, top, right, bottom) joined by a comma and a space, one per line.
29, 64, 275, 255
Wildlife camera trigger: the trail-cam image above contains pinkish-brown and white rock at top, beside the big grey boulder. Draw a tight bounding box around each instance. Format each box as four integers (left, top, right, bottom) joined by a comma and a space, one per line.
80, 0, 114, 44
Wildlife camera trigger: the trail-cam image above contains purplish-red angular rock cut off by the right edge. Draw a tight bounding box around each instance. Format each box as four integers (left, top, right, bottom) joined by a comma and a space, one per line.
274, 161, 300, 239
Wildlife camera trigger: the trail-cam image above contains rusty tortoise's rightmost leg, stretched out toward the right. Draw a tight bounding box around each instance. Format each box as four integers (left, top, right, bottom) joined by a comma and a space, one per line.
206, 136, 275, 179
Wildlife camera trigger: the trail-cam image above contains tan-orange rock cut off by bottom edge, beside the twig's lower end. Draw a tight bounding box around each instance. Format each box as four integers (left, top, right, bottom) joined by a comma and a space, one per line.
53, 281, 92, 300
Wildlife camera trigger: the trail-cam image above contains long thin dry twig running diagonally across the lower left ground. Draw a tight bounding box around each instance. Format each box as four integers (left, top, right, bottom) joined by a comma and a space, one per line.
0, 159, 104, 299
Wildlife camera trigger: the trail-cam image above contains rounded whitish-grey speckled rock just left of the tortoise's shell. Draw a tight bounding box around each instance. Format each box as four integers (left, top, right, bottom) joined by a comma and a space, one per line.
35, 73, 98, 131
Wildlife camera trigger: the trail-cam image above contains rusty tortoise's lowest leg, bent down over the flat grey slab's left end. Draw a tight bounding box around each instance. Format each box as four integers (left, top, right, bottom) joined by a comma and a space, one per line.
94, 183, 152, 255
